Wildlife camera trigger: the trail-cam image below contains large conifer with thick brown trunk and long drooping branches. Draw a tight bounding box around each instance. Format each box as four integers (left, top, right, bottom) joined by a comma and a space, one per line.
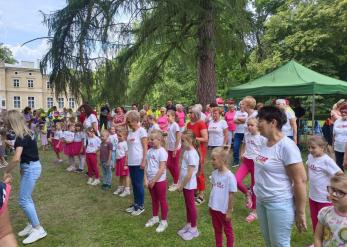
41, 0, 250, 105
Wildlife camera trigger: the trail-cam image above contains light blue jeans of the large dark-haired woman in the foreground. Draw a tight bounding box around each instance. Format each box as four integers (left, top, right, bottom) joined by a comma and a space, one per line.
257, 199, 295, 247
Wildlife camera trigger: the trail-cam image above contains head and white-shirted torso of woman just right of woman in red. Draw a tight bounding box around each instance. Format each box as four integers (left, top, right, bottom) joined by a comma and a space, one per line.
208, 107, 229, 148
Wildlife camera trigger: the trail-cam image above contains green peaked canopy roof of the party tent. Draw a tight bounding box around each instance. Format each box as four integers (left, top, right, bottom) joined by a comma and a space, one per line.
229, 60, 347, 98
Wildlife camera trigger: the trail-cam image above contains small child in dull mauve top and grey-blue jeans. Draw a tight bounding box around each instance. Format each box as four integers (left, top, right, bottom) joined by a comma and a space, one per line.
100, 129, 113, 190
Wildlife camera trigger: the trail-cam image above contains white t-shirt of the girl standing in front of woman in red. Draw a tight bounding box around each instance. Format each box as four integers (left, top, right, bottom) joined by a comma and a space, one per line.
179, 149, 200, 190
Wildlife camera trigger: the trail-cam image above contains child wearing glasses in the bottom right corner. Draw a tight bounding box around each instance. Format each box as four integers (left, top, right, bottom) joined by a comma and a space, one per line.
314, 175, 347, 247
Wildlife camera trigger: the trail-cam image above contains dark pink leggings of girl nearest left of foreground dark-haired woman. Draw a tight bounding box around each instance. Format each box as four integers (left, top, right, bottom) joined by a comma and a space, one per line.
210, 208, 234, 247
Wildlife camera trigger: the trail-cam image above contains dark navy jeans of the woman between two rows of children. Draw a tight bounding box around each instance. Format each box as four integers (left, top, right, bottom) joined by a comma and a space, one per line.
129, 166, 145, 209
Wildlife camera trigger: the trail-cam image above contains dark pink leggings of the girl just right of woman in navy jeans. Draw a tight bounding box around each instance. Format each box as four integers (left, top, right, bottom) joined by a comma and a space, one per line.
148, 180, 169, 220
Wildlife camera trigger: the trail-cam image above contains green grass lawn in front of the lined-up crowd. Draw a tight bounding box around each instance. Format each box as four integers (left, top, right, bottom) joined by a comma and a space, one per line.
2, 148, 313, 247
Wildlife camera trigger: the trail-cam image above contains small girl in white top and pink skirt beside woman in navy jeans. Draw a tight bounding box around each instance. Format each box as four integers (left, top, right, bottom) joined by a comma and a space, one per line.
113, 129, 130, 197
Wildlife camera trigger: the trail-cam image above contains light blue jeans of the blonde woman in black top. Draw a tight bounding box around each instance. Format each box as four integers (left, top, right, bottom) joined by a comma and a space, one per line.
18, 161, 42, 227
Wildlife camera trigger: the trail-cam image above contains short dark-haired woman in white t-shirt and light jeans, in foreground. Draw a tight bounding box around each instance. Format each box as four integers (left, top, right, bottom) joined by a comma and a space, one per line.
254, 106, 307, 247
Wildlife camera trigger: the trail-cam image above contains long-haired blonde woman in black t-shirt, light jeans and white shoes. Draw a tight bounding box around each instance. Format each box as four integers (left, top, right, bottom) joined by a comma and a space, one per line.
4, 110, 47, 244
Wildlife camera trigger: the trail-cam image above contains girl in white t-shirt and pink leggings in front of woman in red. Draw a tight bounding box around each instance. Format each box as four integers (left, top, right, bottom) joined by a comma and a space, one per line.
177, 130, 200, 240
